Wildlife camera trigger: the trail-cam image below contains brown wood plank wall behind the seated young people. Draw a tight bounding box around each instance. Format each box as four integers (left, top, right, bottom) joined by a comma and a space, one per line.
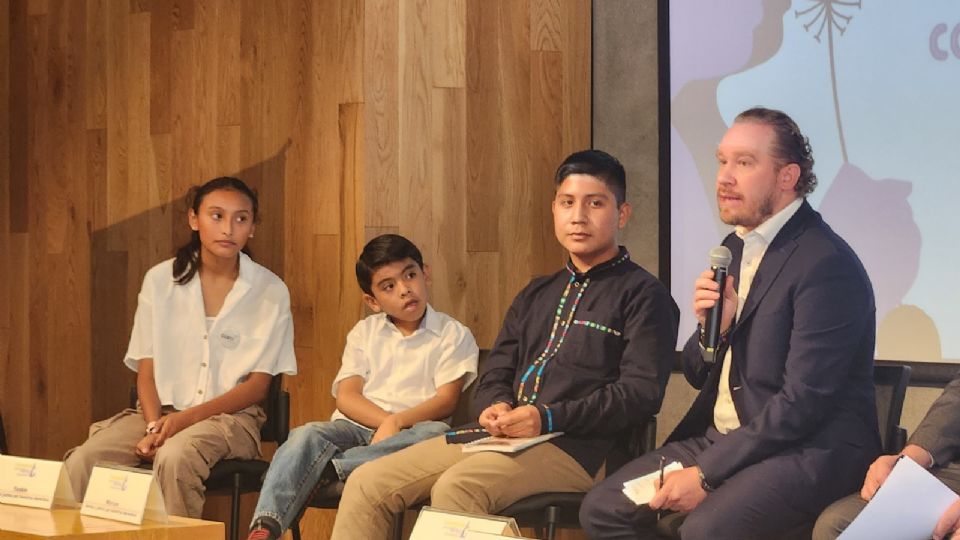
0, 0, 591, 538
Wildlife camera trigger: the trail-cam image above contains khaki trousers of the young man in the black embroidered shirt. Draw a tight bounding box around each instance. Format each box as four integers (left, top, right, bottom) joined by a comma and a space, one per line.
331, 436, 603, 540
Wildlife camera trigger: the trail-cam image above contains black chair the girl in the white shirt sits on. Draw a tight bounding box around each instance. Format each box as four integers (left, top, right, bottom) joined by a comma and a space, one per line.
130, 375, 290, 540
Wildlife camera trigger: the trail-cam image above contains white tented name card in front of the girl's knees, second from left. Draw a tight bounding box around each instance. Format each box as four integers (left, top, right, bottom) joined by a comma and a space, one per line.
80, 464, 167, 525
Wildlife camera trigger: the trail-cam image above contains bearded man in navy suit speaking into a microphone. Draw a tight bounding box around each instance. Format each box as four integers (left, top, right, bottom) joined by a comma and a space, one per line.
580, 108, 880, 540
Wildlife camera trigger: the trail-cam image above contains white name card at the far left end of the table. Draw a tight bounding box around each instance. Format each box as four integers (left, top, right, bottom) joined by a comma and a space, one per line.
0, 456, 78, 509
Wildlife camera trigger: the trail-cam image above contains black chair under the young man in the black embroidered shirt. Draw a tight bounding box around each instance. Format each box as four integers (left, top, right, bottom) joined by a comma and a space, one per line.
497, 417, 657, 540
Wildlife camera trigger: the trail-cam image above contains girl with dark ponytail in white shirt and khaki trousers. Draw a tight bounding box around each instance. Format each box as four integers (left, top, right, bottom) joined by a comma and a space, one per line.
65, 177, 297, 518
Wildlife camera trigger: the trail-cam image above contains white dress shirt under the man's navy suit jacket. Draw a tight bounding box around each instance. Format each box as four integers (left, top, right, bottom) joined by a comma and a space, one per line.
713, 197, 803, 434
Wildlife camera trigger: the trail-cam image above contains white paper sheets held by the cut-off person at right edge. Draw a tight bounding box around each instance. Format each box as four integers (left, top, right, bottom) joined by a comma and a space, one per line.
838, 458, 958, 540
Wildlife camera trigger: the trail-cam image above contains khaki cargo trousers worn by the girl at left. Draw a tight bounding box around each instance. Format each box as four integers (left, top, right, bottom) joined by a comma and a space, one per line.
64, 406, 266, 518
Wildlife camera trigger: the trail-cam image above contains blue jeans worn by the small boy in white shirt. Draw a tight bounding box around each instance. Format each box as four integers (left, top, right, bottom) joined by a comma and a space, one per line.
251, 419, 450, 531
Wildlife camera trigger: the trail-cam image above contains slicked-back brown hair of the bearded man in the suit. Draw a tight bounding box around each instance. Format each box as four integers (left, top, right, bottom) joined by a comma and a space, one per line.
734, 107, 817, 197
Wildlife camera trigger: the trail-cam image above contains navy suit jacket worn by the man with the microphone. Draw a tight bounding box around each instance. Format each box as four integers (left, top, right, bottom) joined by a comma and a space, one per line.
669, 201, 880, 492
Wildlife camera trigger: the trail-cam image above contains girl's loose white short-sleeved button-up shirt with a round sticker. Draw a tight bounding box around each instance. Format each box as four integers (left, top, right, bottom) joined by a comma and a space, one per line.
124, 253, 297, 410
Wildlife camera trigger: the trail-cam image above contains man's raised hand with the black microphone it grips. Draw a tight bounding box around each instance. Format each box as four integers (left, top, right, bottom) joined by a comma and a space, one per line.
693, 246, 737, 363
